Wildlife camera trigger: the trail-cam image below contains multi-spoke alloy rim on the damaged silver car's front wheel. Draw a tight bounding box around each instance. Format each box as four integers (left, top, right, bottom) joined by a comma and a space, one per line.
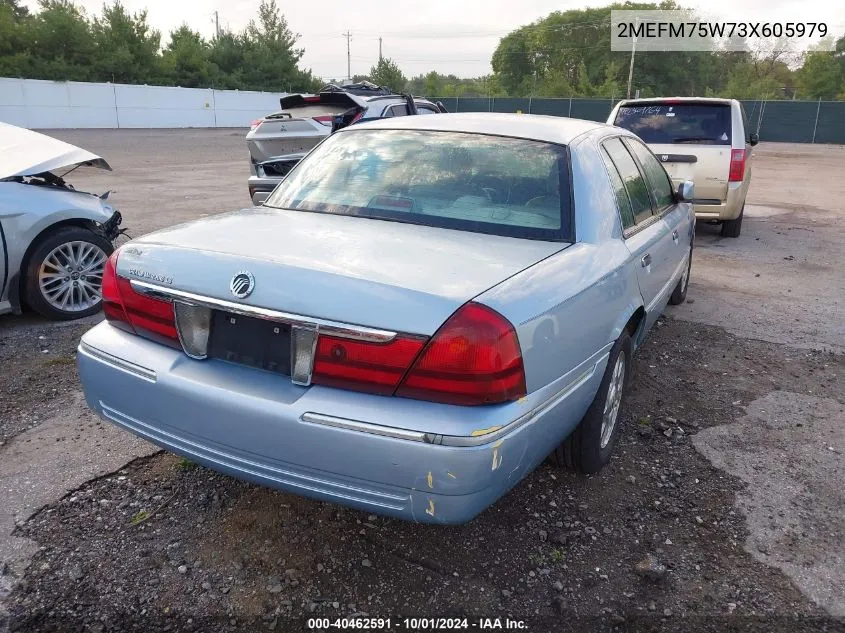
38, 241, 108, 312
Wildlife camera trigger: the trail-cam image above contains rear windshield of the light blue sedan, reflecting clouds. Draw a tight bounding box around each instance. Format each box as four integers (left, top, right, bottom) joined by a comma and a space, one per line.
265, 128, 571, 241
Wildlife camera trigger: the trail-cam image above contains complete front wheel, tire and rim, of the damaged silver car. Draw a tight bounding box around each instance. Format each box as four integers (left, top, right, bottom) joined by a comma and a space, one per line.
23, 226, 114, 321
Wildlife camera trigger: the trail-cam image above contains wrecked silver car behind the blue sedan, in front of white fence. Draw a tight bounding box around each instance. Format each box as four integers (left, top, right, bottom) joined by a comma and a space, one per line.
246, 82, 445, 205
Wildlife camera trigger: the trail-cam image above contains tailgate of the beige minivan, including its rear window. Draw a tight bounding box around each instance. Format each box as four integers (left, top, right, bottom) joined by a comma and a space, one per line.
613, 99, 732, 204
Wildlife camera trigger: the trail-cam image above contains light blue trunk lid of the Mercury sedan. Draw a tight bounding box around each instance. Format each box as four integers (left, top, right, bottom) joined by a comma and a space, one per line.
118, 207, 567, 336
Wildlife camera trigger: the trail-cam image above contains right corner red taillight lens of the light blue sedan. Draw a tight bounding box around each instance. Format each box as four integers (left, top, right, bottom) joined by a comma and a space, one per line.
396, 303, 525, 405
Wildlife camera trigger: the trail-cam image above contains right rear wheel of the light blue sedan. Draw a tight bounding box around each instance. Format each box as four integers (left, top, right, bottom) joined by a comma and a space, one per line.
551, 332, 632, 473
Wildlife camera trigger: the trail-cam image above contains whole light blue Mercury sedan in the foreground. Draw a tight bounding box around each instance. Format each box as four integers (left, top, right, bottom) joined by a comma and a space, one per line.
78, 114, 694, 523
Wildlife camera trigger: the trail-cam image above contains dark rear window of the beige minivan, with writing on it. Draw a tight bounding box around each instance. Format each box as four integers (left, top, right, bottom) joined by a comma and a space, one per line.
614, 103, 731, 145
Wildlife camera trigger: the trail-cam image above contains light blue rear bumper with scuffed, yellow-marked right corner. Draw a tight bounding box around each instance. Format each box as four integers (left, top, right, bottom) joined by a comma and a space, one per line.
72, 323, 606, 523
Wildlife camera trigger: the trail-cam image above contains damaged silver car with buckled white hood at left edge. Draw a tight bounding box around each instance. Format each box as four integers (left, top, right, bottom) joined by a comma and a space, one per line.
0, 123, 121, 320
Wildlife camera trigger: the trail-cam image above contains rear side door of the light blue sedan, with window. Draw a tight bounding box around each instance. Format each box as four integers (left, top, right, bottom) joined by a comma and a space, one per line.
602, 137, 674, 329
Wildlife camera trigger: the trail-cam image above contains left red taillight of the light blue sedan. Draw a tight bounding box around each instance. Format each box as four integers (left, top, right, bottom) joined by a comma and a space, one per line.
102, 251, 179, 342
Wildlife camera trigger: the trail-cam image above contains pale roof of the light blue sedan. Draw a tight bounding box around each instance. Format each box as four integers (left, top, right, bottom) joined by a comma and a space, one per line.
344, 112, 613, 145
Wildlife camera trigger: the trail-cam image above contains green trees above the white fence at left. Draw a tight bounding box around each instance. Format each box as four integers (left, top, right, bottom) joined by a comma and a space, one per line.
0, 0, 321, 92
